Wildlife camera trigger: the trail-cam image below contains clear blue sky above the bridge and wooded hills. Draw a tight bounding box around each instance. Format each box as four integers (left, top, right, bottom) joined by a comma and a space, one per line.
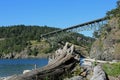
0, 0, 117, 36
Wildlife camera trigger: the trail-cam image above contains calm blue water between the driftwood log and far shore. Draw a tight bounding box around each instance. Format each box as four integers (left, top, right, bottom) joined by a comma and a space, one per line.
0, 58, 48, 77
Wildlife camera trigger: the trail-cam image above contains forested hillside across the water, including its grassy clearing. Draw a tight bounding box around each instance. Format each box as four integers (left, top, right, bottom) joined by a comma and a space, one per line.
0, 25, 94, 57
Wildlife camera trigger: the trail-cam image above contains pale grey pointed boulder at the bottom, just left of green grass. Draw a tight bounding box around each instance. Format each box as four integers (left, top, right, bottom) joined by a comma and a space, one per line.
90, 66, 108, 80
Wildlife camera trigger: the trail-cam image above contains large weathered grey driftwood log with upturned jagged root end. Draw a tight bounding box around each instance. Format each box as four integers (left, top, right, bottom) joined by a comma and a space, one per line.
9, 43, 79, 80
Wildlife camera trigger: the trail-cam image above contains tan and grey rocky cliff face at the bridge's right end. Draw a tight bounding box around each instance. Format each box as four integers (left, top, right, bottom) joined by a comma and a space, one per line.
90, 18, 120, 60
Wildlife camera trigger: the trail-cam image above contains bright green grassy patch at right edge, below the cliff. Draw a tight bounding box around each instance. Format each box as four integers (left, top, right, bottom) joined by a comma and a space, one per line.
103, 63, 120, 77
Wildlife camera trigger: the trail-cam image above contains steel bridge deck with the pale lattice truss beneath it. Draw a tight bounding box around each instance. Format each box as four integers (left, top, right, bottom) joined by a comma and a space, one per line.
40, 17, 108, 41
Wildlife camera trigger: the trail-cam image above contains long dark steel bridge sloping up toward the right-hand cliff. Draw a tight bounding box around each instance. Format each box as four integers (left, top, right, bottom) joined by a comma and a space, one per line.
40, 17, 109, 38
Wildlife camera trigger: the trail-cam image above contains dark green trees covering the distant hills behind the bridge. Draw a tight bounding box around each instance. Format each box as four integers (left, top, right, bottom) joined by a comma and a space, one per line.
0, 25, 94, 54
